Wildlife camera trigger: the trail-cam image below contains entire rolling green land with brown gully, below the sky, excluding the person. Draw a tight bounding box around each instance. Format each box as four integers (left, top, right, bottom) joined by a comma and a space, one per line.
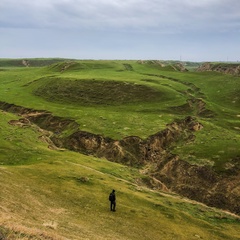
0, 59, 240, 239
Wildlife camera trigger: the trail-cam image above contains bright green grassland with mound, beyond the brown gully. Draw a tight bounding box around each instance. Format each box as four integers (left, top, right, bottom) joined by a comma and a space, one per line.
0, 60, 240, 166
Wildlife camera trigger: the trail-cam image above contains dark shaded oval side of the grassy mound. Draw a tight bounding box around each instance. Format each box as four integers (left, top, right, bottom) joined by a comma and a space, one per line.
34, 78, 165, 105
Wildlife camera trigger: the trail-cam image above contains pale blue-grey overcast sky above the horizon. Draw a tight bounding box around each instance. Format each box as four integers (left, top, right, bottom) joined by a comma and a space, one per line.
0, 0, 240, 61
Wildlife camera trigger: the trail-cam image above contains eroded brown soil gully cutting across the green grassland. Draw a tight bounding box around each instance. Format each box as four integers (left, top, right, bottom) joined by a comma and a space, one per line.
0, 102, 240, 214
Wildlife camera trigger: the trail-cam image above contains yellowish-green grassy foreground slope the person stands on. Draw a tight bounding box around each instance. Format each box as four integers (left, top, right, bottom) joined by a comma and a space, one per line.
0, 111, 239, 240
